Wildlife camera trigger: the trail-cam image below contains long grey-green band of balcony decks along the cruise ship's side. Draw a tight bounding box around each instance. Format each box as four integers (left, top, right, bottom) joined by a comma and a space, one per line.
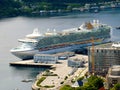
37, 30, 109, 48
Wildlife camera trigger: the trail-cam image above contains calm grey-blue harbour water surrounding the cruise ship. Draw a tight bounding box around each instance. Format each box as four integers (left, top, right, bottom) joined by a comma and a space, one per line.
0, 10, 120, 90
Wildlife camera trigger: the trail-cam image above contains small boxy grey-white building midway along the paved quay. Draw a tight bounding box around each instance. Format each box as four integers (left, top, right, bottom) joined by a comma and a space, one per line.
68, 59, 83, 68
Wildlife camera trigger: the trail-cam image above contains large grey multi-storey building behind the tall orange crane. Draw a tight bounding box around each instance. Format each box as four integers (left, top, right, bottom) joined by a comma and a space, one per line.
88, 43, 120, 75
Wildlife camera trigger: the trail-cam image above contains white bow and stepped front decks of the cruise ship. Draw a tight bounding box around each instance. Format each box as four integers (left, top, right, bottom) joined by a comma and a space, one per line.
10, 28, 43, 59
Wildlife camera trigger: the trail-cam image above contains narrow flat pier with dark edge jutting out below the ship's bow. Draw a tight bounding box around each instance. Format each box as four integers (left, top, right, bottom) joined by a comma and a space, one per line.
9, 60, 53, 67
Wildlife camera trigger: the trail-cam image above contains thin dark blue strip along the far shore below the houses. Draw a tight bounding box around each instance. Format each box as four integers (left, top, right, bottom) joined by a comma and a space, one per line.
0, 7, 120, 20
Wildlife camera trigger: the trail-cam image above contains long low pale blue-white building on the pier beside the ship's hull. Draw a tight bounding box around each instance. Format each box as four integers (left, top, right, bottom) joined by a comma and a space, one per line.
34, 54, 58, 64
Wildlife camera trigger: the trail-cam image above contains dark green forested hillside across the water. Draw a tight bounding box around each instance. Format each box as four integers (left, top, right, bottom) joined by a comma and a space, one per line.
0, 0, 118, 18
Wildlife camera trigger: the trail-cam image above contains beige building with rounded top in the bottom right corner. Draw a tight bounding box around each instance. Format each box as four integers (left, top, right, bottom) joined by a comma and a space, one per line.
106, 65, 120, 89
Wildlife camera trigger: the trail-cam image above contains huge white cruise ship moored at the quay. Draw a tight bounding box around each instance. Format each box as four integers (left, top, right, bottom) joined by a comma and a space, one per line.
10, 20, 111, 60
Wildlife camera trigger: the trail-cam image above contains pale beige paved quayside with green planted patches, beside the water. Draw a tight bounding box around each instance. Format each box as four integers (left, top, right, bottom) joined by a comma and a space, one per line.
31, 55, 88, 90
